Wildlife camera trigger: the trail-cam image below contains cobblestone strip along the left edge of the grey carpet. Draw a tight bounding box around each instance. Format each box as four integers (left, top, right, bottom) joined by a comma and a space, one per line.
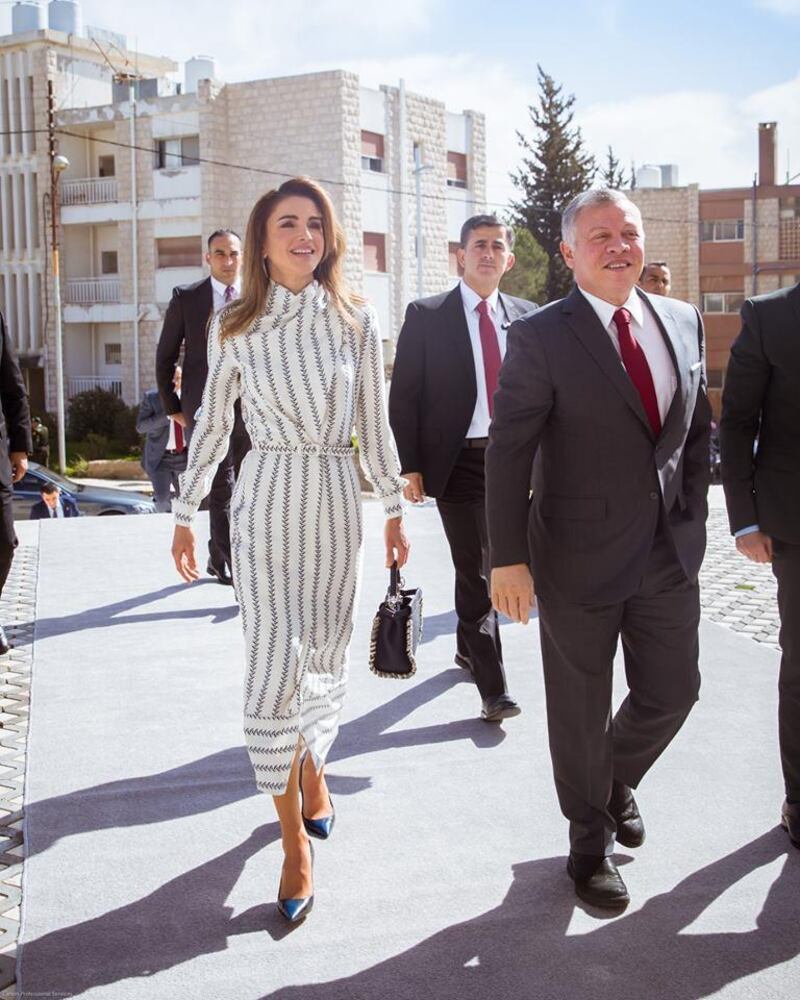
0, 544, 39, 997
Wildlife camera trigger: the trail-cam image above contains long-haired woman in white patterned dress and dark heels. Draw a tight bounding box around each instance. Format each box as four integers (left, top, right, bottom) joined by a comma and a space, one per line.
172, 178, 408, 922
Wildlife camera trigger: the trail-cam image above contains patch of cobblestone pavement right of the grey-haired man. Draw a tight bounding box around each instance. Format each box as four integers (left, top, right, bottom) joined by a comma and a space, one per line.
700, 510, 779, 649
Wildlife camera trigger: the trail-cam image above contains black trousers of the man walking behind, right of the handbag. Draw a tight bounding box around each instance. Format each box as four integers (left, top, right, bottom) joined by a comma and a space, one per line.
436, 448, 506, 698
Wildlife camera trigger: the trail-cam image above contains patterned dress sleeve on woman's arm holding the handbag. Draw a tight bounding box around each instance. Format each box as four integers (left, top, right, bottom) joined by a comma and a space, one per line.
356, 309, 405, 518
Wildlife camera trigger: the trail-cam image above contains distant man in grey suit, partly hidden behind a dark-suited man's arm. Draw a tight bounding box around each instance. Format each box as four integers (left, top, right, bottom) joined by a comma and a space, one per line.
136, 365, 188, 513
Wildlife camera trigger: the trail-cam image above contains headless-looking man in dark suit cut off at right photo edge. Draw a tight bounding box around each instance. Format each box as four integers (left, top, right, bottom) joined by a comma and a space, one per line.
720, 284, 800, 847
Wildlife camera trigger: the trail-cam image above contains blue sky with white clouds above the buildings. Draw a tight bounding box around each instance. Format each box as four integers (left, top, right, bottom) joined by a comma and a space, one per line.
0, 0, 800, 208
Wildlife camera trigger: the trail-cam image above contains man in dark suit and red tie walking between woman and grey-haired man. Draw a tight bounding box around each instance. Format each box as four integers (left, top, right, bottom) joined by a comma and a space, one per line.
389, 215, 536, 722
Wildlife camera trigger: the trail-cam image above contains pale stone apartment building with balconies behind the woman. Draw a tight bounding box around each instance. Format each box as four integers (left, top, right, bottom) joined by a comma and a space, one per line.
0, 0, 486, 409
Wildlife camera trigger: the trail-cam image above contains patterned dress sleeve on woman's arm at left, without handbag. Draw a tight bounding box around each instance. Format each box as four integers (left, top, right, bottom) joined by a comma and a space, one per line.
172, 317, 241, 525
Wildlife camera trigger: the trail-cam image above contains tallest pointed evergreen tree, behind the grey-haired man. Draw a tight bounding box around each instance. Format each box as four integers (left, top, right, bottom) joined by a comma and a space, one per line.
511, 66, 597, 301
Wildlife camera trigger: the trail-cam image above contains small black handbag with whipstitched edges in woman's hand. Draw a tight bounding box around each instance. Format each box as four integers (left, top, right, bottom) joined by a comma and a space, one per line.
369, 562, 422, 678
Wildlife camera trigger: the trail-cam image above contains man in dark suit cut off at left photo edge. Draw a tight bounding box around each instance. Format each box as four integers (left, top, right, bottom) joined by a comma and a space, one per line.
0, 313, 33, 655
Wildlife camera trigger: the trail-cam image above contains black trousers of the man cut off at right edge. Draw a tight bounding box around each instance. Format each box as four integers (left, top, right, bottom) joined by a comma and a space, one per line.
772, 538, 800, 802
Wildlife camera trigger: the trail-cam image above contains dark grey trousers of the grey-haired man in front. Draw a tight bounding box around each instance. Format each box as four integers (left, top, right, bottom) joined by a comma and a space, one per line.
534, 529, 700, 855
